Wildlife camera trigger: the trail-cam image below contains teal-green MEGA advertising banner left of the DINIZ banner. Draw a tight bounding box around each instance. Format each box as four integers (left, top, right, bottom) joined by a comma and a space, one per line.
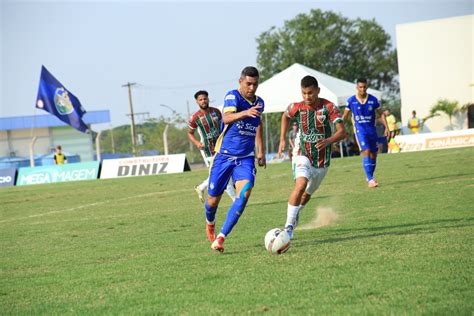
16, 161, 100, 185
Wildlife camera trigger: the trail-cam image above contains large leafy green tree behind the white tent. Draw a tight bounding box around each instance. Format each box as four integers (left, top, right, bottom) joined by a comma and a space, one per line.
257, 9, 399, 95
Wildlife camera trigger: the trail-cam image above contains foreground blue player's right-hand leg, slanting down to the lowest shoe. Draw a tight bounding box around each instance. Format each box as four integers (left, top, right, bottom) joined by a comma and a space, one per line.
212, 157, 256, 251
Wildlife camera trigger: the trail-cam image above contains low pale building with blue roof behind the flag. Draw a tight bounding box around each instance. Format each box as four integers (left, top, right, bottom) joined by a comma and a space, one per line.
0, 110, 110, 162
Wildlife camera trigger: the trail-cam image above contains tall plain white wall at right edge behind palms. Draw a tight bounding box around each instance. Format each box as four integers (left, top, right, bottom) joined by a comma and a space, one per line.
396, 15, 474, 132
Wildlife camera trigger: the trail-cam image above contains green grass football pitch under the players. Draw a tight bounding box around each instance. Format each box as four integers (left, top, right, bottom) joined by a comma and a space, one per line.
0, 148, 474, 315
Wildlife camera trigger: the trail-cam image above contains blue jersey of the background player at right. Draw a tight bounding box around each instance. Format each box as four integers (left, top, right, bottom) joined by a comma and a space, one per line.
347, 94, 380, 134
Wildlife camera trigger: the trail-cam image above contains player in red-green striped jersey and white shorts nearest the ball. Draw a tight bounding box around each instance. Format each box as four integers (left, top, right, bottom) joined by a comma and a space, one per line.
278, 76, 346, 238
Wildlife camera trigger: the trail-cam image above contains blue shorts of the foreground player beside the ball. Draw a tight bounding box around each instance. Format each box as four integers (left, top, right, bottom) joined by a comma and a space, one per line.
207, 153, 257, 196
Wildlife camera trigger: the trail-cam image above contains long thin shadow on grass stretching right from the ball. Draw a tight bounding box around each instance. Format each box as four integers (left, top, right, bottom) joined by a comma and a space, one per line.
298, 217, 474, 246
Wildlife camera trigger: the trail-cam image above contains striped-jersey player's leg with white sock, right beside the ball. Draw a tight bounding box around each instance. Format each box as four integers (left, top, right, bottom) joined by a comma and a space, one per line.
285, 156, 311, 236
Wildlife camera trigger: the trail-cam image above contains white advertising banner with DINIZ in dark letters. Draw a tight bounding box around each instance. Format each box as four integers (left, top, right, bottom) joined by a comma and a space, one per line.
100, 154, 191, 179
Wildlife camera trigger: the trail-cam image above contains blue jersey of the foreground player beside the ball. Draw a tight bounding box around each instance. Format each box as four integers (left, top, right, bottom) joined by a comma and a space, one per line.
216, 90, 264, 157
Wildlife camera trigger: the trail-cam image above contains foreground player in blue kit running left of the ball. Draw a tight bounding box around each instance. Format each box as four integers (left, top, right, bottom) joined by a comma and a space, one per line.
204, 66, 266, 252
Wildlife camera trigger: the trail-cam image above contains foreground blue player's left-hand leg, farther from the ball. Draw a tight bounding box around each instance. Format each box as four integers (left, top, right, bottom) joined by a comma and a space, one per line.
204, 154, 233, 241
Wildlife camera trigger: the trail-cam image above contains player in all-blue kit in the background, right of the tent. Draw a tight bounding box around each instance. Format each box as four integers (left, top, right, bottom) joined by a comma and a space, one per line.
343, 79, 388, 188
